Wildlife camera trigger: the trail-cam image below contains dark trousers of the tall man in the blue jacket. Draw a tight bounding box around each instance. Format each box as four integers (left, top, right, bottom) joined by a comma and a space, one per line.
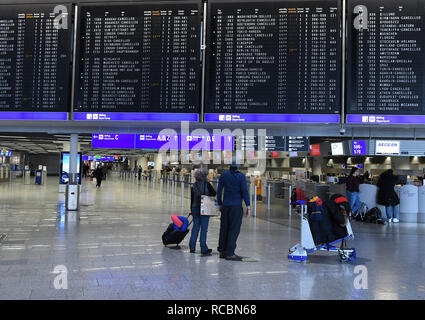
217, 206, 243, 257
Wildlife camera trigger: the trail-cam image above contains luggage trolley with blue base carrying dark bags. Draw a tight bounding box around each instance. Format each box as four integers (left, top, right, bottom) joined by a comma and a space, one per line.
288, 200, 357, 262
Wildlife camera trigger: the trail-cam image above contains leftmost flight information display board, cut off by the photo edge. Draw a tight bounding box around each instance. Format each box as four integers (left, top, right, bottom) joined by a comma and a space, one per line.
0, 4, 71, 120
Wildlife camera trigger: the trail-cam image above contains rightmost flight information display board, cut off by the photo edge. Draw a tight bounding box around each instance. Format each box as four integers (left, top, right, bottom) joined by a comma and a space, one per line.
347, 0, 425, 124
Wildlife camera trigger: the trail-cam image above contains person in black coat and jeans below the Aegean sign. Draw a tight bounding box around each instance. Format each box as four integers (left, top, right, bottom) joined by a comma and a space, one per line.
377, 169, 400, 222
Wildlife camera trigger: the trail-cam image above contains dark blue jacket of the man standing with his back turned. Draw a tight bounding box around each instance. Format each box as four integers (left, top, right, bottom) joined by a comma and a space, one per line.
217, 169, 251, 206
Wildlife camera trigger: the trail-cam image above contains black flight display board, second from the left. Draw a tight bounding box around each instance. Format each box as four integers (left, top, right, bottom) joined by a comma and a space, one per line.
74, 1, 201, 121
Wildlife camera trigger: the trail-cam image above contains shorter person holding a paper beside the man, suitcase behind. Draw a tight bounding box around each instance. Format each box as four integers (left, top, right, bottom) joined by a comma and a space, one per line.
189, 169, 217, 256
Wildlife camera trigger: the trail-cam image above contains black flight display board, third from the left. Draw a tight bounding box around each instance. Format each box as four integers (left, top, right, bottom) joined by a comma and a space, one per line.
205, 0, 341, 123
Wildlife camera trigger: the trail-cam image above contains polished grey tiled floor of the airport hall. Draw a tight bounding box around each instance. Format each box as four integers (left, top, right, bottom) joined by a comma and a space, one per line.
0, 172, 425, 300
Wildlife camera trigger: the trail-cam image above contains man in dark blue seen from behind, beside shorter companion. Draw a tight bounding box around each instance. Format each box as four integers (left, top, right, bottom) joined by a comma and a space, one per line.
217, 158, 251, 261
